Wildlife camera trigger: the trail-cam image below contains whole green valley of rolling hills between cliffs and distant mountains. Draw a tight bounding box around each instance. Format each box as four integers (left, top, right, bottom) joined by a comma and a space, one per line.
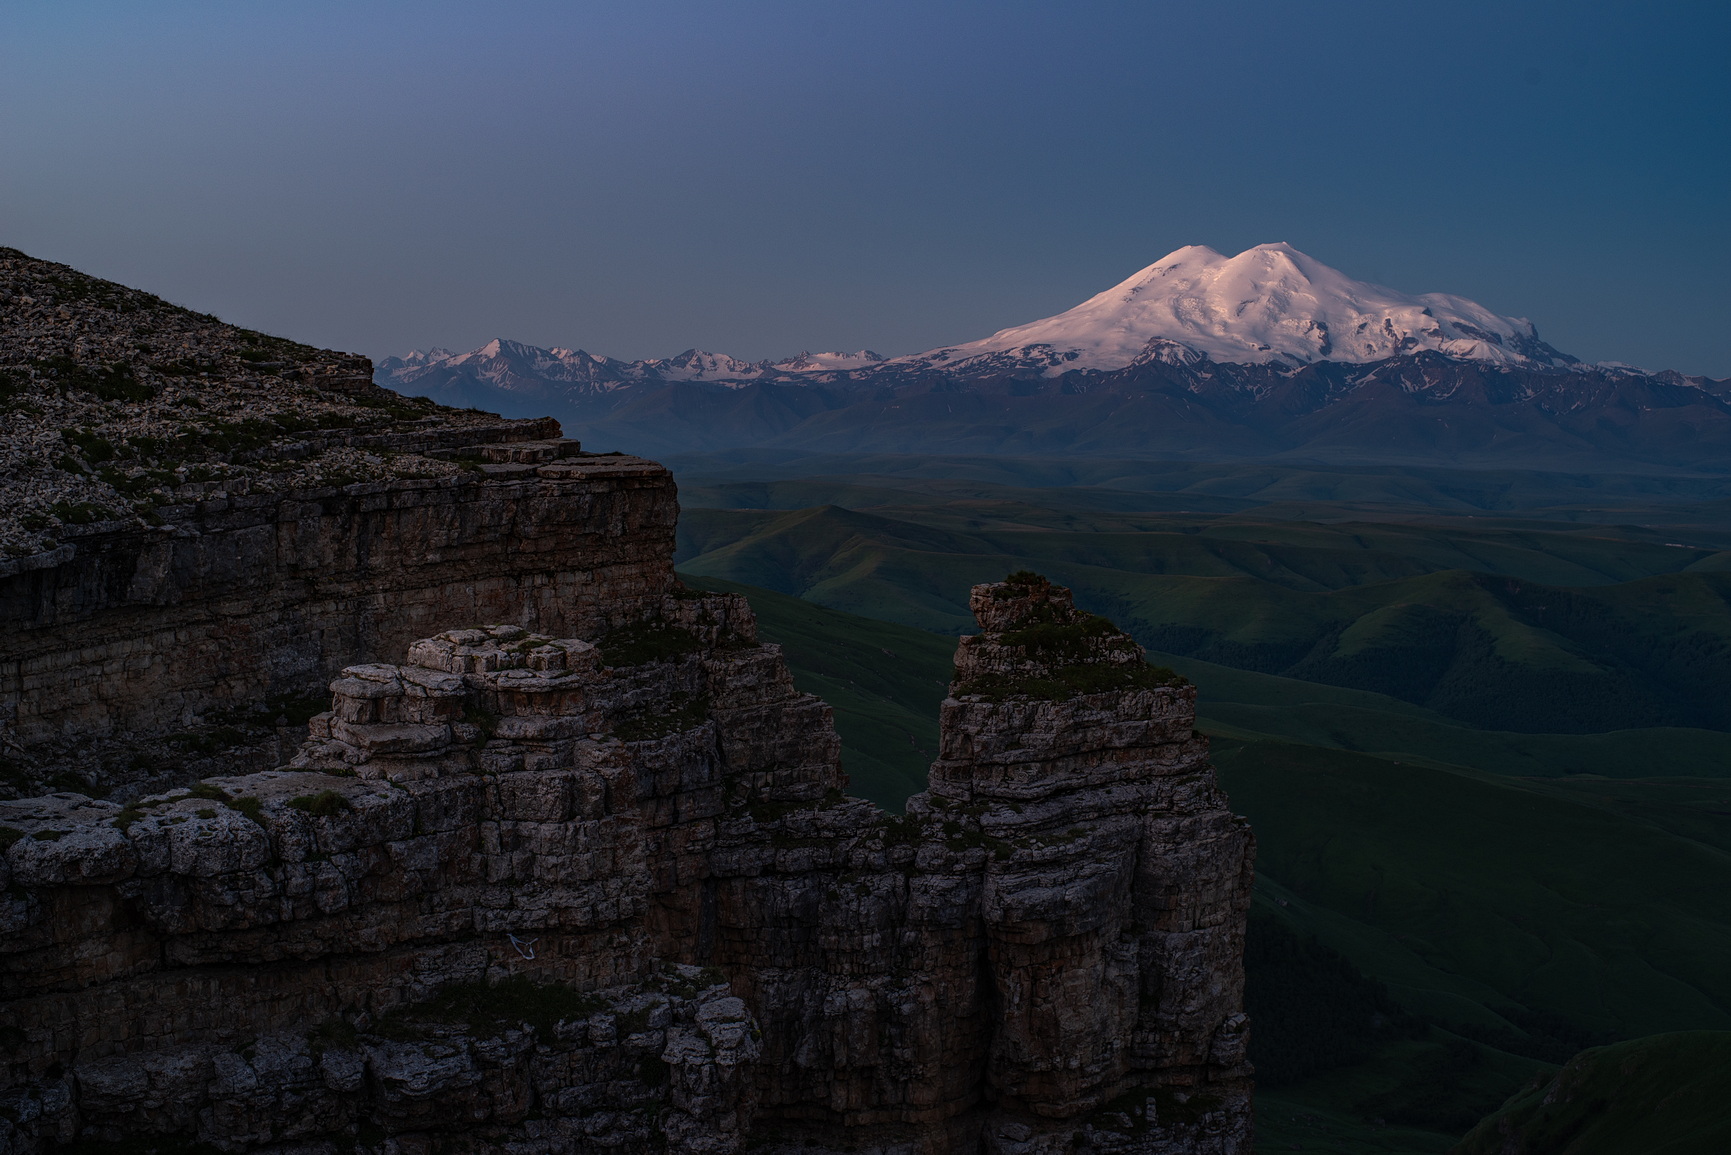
668, 450, 1731, 1152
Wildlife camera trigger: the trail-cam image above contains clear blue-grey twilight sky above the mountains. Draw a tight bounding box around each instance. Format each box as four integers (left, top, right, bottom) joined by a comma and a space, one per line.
0, 0, 1731, 376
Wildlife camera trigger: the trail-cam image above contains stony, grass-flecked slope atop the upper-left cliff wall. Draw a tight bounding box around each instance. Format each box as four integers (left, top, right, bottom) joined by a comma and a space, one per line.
0, 248, 588, 561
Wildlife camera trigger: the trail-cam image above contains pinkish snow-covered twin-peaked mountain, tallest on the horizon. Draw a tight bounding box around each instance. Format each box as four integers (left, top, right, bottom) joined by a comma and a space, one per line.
905, 242, 1575, 374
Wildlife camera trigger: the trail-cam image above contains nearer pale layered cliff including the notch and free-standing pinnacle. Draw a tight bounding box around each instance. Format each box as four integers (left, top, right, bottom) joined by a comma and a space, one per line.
0, 574, 1252, 1155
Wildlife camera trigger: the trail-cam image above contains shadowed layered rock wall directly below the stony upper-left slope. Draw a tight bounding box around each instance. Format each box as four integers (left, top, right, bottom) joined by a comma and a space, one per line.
0, 446, 679, 797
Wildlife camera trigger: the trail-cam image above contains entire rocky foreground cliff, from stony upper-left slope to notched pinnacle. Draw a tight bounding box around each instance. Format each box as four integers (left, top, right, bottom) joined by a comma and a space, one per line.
0, 255, 1253, 1155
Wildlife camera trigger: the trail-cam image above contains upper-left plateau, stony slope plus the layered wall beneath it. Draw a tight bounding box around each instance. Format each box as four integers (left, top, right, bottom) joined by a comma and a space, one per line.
0, 249, 677, 797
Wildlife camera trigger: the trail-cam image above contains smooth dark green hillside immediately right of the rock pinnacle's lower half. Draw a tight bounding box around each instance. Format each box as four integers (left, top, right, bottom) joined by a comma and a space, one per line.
1215, 741, 1731, 1053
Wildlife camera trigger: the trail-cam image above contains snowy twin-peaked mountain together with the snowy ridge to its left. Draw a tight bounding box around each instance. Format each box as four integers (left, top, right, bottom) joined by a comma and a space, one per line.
381, 242, 1579, 398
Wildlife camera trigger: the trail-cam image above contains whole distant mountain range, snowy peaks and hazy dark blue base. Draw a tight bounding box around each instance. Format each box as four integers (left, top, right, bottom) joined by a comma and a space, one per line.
377, 244, 1731, 471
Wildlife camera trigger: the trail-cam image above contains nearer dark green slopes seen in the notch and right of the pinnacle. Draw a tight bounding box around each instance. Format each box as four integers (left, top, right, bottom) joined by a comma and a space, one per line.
671, 561, 1731, 1153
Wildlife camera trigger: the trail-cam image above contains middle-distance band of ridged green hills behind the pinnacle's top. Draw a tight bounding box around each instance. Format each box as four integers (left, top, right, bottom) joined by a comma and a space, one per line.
680, 506, 1731, 732
